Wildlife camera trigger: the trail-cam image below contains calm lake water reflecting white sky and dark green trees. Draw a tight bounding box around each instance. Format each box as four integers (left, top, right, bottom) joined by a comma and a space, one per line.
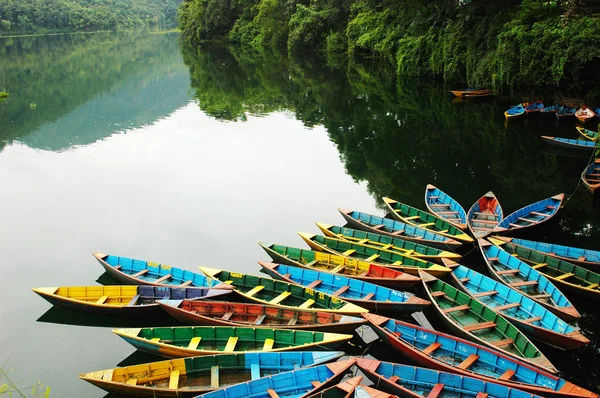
0, 33, 600, 397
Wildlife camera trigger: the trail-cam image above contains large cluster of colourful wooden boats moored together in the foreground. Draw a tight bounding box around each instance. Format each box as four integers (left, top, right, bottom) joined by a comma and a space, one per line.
33, 185, 600, 398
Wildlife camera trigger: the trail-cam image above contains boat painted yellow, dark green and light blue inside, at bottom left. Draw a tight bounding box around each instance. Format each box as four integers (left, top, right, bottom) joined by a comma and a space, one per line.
79, 351, 344, 397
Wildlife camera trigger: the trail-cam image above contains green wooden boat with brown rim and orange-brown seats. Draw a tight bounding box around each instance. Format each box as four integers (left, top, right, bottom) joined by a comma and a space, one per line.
420, 271, 557, 373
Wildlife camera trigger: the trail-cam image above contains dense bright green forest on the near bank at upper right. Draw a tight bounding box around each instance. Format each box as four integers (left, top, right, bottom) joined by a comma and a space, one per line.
179, 0, 600, 89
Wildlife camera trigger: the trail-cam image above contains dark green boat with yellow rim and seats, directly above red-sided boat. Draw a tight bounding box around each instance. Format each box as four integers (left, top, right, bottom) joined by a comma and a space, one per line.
200, 267, 368, 315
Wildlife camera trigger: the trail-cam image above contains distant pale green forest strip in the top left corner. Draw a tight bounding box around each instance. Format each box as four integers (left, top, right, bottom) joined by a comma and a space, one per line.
0, 0, 181, 36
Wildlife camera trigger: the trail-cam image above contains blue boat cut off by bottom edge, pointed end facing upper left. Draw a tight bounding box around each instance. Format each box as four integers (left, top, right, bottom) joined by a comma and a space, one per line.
356, 358, 534, 398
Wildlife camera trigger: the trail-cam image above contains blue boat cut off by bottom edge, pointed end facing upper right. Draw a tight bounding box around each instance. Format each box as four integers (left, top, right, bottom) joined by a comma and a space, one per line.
191, 358, 356, 398
